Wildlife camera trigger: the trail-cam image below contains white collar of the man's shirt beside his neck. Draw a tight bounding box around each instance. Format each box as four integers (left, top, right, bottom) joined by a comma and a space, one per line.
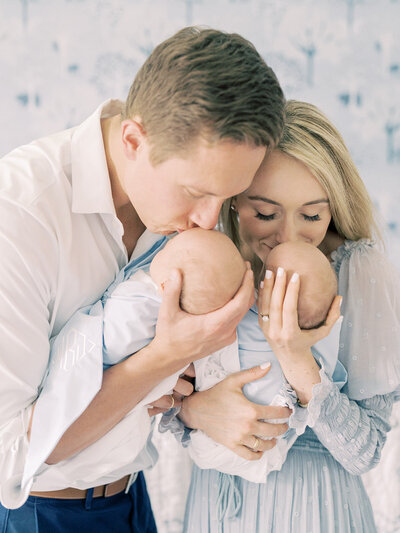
71, 100, 123, 215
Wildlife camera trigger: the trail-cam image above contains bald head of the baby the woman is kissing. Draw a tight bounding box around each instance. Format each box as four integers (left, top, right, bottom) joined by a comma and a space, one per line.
267, 242, 337, 329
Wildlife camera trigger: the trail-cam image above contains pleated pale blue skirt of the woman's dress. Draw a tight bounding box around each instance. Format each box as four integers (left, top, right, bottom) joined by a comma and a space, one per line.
184, 430, 377, 533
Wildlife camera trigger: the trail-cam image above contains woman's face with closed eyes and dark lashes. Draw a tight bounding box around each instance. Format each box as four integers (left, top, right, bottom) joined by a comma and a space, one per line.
232, 150, 331, 262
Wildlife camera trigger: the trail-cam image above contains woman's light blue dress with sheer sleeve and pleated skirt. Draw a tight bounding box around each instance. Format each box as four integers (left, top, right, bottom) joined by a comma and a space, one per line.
184, 240, 400, 533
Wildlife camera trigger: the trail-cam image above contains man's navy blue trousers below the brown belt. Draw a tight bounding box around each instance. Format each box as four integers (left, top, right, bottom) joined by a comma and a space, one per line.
0, 472, 157, 533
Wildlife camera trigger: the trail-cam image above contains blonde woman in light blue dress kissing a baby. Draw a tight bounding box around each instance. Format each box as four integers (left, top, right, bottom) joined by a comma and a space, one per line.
181, 101, 400, 533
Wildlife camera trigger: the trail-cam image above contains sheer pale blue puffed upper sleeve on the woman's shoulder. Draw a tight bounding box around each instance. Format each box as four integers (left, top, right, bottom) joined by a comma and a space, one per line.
332, 239, 400, 400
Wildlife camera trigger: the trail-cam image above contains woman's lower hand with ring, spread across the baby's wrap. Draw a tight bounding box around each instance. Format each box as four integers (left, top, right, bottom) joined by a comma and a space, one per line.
179, 366, 291, 460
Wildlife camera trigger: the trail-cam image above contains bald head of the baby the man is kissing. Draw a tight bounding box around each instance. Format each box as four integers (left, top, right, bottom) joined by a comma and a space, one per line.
150, 228, 246, 315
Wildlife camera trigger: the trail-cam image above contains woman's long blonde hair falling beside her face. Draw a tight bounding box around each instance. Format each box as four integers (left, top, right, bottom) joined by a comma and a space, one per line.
220, 100, 381, 254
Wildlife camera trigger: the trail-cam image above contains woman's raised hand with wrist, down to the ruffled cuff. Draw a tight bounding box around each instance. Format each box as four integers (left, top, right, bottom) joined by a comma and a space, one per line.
257, 268, 341, 405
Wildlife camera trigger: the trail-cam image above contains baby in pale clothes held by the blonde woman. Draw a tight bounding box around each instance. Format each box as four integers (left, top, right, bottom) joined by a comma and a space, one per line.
188, 242, 346, 483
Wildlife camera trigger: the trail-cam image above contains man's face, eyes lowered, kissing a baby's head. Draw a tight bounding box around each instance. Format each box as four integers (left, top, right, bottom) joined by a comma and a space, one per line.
121, 134, 265, 235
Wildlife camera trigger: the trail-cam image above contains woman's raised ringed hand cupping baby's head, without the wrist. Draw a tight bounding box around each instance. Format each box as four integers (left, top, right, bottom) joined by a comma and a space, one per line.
257, 268, 342, 360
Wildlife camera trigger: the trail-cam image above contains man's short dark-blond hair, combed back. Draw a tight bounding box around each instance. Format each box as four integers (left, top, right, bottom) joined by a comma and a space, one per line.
122, 27, 284, 164
